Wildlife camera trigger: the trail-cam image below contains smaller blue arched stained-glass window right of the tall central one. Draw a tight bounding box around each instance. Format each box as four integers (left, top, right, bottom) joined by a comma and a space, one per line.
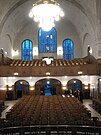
63, 39, 74, 60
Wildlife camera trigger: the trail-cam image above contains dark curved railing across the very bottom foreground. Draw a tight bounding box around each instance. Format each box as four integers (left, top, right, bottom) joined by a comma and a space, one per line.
0, 125, 101, 135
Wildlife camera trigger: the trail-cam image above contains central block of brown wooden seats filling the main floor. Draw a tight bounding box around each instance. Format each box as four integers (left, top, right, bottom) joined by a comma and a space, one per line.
2, 95, 98, 126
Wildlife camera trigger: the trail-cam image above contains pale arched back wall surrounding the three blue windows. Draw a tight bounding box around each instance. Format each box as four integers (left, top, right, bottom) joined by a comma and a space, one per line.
13, 20, 82, 58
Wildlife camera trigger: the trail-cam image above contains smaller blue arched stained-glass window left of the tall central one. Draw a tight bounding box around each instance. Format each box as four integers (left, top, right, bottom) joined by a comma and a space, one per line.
21, 39, 33, 61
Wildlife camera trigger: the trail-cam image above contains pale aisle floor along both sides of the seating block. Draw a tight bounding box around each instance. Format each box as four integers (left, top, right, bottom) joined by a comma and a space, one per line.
1, 97, 101, 121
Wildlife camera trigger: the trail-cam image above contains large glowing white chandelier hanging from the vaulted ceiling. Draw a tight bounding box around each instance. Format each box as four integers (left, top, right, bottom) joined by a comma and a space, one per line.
29, 0, 64, 31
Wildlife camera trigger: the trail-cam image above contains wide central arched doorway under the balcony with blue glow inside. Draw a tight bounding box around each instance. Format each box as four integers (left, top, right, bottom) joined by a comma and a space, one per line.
35, 78, 62, 96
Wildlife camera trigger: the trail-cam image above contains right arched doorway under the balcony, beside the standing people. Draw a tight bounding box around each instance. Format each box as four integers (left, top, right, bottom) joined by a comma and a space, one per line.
67, 79, 83, 102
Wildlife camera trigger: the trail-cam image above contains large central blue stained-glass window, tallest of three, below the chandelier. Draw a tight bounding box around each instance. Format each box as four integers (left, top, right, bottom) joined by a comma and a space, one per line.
38, 28, 57, 53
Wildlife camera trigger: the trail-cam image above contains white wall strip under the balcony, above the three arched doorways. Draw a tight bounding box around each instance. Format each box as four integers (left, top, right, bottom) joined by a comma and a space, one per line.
0, 75, 100, 90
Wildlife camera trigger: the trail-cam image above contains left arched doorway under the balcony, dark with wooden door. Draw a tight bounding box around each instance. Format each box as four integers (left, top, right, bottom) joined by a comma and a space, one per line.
14, 80, 29, 99
